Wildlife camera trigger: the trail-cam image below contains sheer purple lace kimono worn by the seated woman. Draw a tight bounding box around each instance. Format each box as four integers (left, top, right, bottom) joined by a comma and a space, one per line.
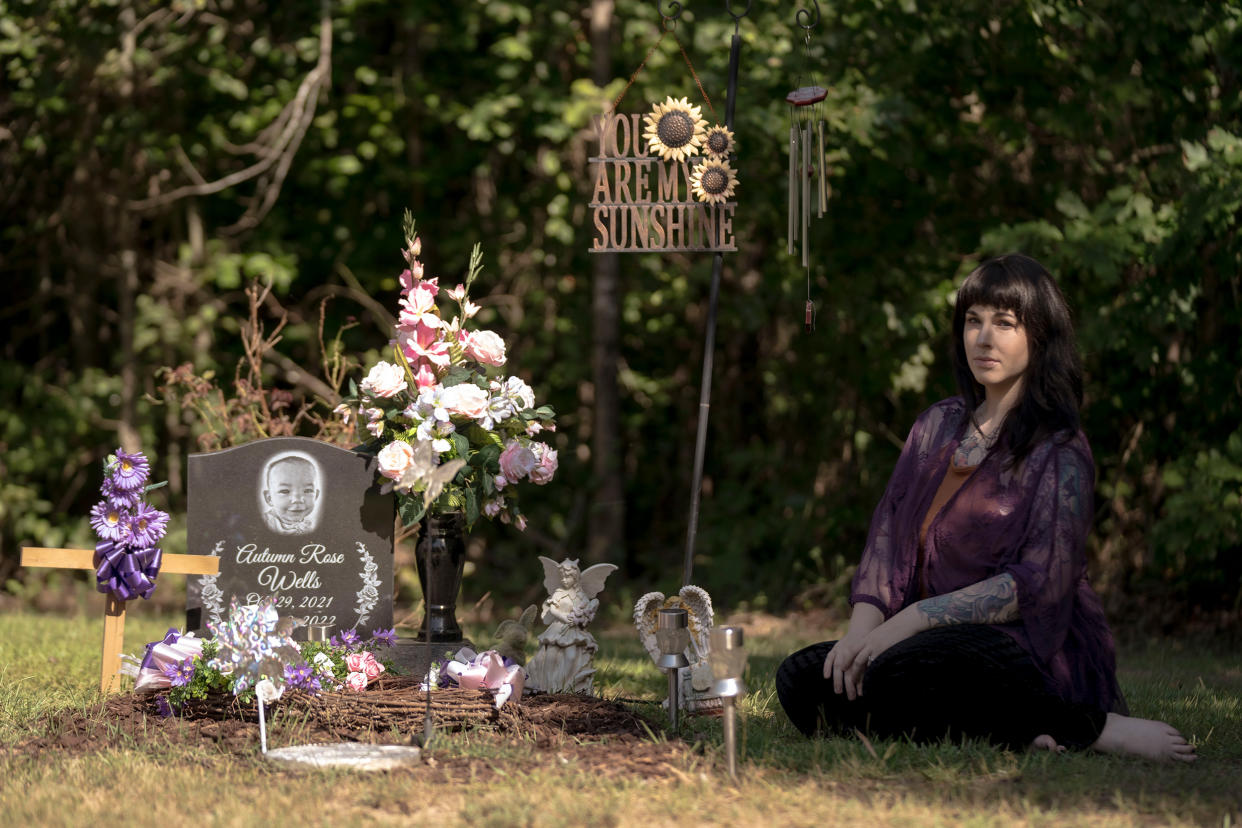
851, 397, 1125, 711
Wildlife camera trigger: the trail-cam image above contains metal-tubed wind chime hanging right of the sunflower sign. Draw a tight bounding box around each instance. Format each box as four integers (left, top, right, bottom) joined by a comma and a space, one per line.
785, 5, 828, 331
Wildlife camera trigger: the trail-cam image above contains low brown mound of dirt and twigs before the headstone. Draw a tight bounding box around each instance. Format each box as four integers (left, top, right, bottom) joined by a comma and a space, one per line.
16, 677, 689, 778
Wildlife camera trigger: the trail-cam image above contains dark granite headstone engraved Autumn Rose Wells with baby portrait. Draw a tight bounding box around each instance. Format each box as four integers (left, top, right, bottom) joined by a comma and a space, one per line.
186, 437, 396, 638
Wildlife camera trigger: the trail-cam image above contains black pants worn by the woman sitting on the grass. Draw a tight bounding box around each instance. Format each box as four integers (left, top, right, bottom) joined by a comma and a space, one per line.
776, 624, 1107, 750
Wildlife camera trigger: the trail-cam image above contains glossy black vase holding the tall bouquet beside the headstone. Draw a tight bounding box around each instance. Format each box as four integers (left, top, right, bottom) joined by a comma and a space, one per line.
415, 511, 466, 643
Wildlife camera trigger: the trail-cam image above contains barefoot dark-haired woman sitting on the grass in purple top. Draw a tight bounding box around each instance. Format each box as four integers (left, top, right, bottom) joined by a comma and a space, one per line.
776, 254, 1195, 761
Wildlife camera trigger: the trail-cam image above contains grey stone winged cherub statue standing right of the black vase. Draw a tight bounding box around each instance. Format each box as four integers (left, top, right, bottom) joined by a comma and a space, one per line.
527, 555, 616, 693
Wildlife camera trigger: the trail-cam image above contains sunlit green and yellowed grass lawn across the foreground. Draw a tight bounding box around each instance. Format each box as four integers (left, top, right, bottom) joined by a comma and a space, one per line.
0, 608, 1242, 826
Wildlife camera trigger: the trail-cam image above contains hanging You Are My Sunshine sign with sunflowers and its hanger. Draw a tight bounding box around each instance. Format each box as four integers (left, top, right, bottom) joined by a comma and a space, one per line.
590, 19, 738, 253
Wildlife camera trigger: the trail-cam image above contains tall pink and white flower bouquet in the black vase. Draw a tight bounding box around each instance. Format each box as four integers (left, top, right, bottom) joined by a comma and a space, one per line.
335, 211, 558, 529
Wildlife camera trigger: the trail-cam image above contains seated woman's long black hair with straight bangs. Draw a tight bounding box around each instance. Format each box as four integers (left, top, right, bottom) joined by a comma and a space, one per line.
953, 253, 1083, 463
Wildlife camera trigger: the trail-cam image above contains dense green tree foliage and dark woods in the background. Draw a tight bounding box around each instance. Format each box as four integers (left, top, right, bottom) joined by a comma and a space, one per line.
0, 0, 1242, 623
